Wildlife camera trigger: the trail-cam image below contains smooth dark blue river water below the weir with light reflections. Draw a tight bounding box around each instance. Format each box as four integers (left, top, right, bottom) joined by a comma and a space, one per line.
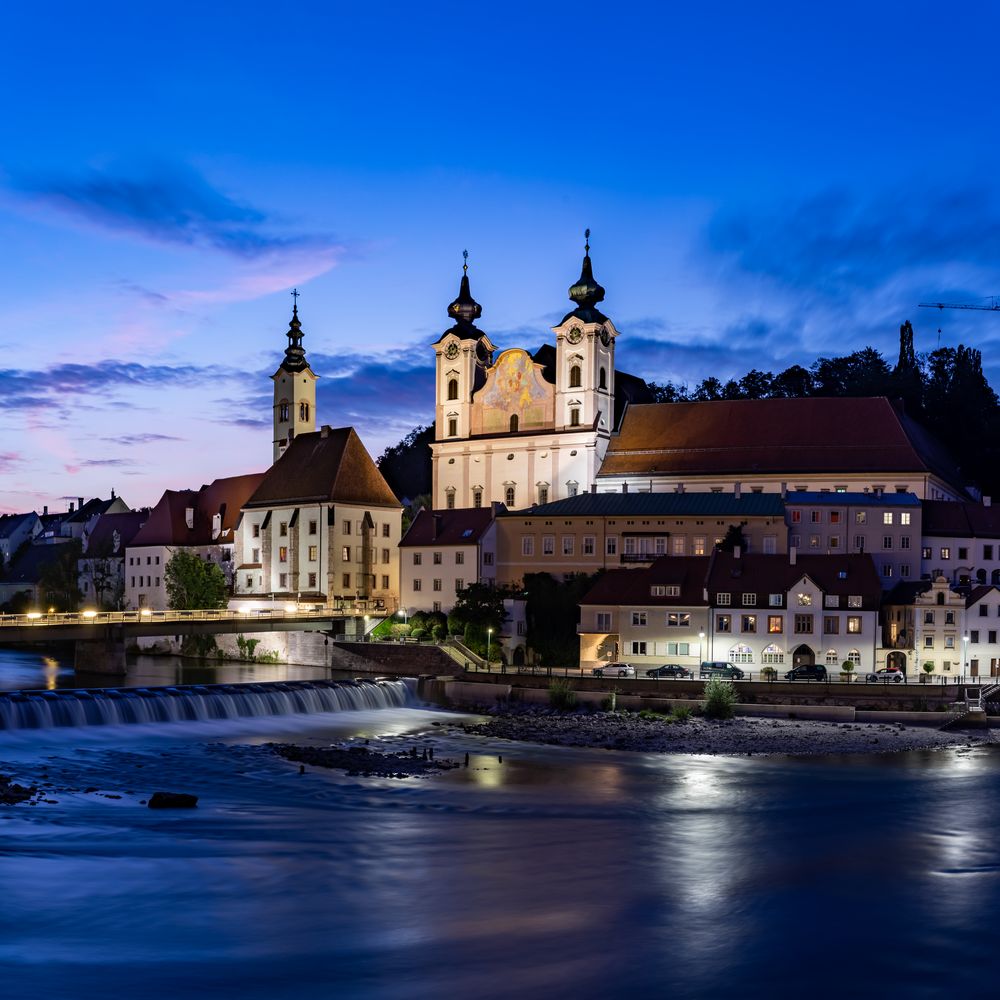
0, 644, 1000, 1000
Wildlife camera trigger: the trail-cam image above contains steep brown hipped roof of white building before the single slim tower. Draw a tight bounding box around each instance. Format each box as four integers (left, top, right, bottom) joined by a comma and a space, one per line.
243, 426, 399, 508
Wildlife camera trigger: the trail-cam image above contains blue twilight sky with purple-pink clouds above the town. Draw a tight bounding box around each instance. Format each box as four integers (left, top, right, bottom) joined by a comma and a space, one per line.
0, 0, 1000, 511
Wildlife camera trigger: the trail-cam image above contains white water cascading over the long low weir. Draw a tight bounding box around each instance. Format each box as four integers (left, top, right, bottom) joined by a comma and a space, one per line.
0, 678, 413, 730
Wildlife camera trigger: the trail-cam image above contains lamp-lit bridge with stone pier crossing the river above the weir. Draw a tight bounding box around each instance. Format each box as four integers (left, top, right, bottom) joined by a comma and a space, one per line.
0, 602, 388, 674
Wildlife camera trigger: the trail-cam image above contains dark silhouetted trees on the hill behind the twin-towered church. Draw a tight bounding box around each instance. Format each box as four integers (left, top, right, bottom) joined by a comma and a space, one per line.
378, 322, 1000, 498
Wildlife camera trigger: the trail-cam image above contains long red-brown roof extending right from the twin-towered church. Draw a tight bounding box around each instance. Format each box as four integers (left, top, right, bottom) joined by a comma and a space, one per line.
598, 396, 960, 485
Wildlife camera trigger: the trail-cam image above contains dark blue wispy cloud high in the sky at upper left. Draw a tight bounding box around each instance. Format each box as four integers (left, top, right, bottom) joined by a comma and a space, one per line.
11, 164, 343, 262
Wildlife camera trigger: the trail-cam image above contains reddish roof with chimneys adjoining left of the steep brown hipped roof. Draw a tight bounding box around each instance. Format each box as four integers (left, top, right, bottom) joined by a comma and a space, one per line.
129, 472, 265, 548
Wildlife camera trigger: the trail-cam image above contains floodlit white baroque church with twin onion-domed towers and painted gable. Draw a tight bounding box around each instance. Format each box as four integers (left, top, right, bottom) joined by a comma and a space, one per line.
431, 238, 652, 510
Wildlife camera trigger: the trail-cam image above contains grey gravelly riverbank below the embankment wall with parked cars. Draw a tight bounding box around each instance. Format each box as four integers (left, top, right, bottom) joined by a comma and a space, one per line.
460, 709, 991, 756
